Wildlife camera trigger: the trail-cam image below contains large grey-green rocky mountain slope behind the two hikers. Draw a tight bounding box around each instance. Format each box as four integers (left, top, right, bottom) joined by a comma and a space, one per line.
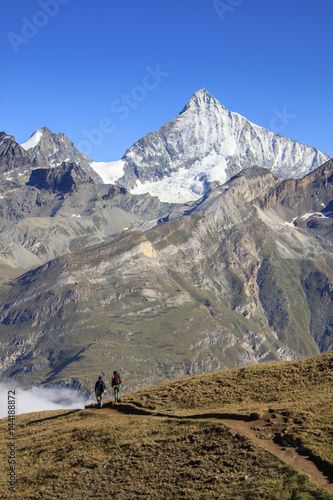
0, 163, 333, 388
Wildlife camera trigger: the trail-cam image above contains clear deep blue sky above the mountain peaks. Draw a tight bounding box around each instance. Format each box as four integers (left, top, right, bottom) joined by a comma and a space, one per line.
0, 0, 333, 161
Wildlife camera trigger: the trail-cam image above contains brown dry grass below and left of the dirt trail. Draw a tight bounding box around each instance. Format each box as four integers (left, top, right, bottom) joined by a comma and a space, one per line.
1, 410, 330, 500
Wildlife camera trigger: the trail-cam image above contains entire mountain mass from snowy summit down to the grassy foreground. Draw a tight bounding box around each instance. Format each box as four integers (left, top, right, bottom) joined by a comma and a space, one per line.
0, 89, 333, 392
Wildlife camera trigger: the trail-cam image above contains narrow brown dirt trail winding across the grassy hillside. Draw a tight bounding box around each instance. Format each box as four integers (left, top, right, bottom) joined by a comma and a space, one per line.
89, 405, 333, 495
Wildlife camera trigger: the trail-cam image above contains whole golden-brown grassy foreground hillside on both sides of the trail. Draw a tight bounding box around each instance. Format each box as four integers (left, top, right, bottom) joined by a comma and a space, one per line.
0, 352, 333, 500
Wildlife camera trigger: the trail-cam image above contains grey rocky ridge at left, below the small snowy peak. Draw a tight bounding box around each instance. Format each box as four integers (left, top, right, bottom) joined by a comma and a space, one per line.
0, 133, 178, 274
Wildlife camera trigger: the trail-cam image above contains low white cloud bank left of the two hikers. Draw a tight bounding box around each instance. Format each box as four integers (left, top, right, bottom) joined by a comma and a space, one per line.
0, 383, 92, 418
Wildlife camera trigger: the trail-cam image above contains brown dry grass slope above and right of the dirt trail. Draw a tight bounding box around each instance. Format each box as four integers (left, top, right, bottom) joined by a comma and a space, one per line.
122, 351, 333, 476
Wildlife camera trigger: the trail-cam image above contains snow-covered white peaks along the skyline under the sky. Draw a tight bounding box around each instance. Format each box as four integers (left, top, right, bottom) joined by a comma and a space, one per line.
22, 89, 330, 203
